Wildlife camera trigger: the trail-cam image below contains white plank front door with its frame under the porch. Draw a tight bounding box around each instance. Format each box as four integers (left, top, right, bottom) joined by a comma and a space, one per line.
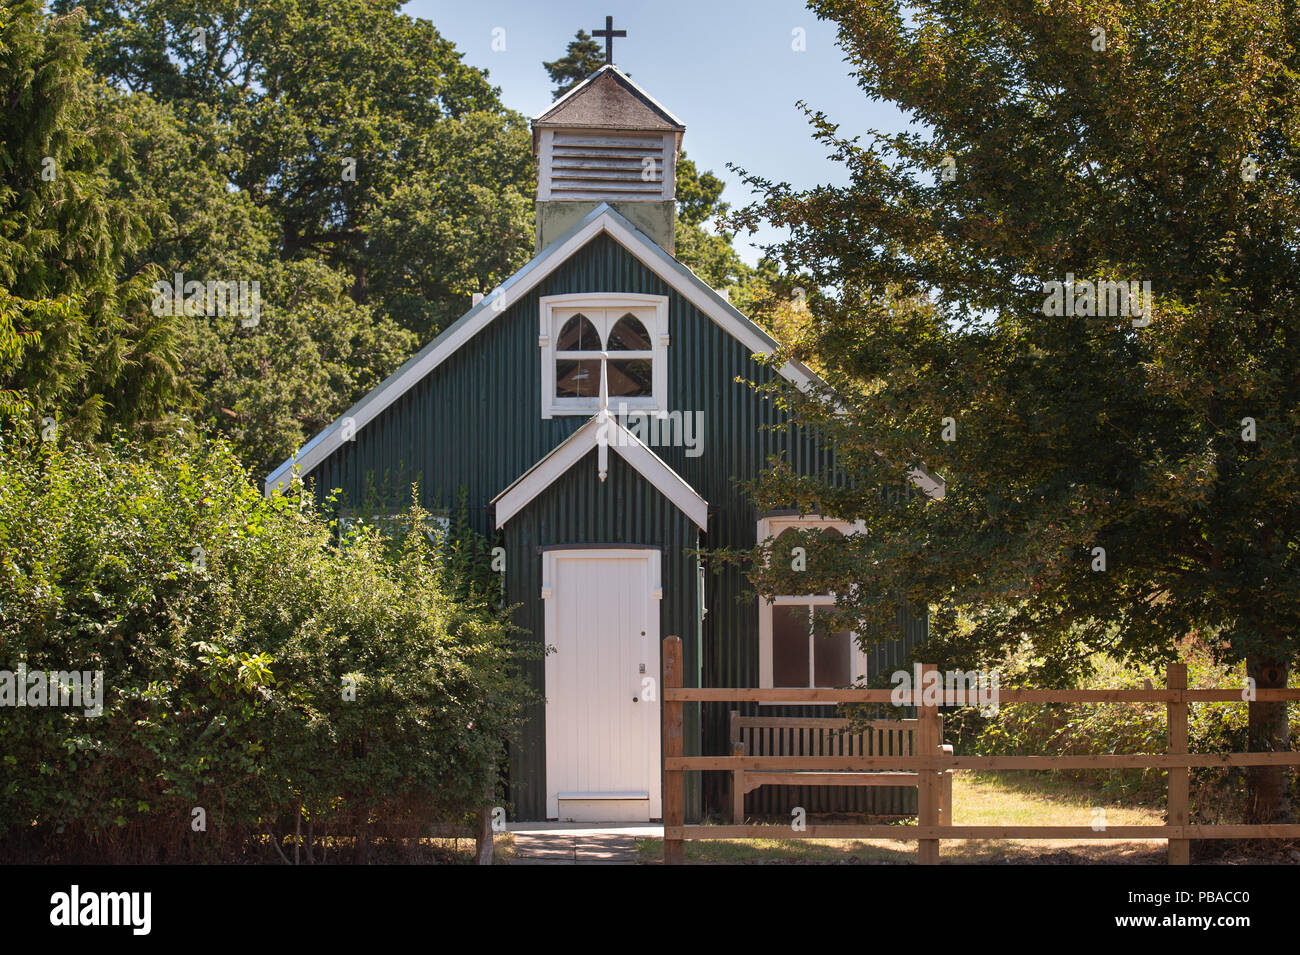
542, 548, 662, 821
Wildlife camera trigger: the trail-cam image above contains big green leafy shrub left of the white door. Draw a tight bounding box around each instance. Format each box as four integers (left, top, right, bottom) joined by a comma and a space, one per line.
0, 428, 530, 860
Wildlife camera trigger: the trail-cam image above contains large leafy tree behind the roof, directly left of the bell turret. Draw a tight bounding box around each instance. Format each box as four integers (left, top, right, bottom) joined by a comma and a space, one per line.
65, 0, 534, 340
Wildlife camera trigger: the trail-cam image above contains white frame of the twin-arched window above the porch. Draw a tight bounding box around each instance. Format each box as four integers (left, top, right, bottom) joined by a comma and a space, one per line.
537, 292, 670, 418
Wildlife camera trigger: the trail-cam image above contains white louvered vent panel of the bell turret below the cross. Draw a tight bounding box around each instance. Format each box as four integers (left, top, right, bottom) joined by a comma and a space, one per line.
538, 130, 676, 200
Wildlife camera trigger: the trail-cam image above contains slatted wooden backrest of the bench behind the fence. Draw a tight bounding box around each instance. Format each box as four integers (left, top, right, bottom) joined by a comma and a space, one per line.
731, 709, 919, 756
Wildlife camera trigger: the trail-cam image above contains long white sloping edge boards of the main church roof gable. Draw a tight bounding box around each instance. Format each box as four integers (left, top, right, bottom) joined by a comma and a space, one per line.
264, 203, 824, 494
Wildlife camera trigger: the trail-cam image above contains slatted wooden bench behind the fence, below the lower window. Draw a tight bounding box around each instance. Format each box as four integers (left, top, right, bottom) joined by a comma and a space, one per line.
731, 709, 953, 825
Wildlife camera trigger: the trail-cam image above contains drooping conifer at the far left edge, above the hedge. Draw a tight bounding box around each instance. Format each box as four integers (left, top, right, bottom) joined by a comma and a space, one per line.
0, 3, 182, 438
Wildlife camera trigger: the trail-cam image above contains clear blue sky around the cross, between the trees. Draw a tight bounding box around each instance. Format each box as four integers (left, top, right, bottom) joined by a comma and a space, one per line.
403, 0, 904, 262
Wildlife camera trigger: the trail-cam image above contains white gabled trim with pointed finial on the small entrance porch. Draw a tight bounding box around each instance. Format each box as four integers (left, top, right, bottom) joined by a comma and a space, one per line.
491, 411, 709, 530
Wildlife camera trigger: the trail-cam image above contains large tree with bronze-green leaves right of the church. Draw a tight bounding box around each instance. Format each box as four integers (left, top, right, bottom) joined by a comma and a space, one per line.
731, 0, 1300, 815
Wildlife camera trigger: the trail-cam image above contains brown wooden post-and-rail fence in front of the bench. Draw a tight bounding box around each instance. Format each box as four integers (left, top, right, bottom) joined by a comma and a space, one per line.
663, 637, 1300, 865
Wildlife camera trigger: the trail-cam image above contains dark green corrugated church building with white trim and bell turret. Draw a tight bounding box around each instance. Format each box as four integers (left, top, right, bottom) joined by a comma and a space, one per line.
265, 44, 927, 821
